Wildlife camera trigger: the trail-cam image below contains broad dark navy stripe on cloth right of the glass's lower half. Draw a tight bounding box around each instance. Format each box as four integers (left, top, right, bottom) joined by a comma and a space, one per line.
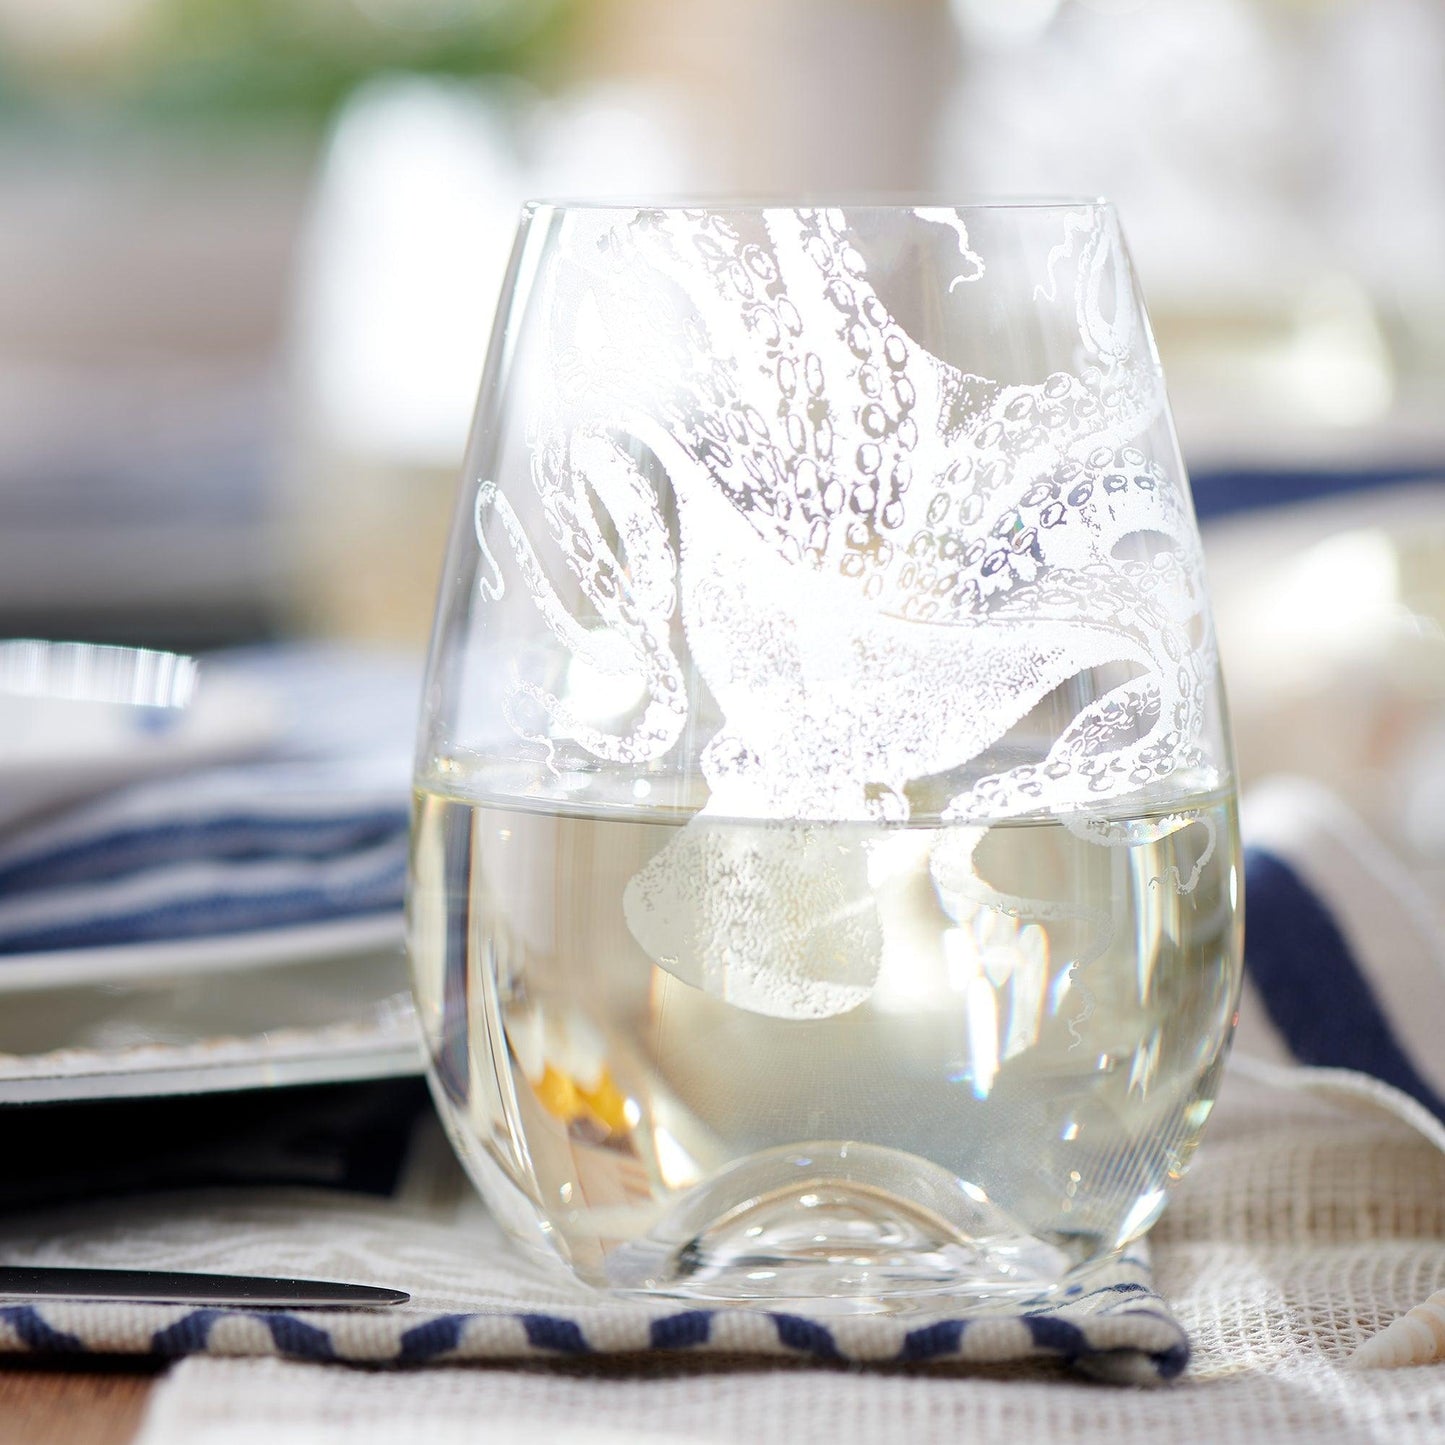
1244, 848, 1445, 1120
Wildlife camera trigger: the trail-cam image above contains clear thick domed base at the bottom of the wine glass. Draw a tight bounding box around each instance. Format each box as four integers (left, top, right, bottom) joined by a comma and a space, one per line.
607, 1143, 1078, 1314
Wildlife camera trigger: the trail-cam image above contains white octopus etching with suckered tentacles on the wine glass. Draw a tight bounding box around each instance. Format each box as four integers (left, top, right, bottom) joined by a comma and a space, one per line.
475, 210, 1212, 1016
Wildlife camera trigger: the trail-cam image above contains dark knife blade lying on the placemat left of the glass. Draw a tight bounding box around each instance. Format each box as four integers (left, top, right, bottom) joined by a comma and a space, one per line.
0, 1264, 412, 1309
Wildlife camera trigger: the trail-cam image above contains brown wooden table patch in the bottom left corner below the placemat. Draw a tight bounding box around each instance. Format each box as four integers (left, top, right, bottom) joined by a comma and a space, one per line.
0, 1363, 159, 1445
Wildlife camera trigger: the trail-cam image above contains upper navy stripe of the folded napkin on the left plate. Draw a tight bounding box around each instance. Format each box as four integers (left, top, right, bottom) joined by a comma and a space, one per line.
0, 806, 407, 896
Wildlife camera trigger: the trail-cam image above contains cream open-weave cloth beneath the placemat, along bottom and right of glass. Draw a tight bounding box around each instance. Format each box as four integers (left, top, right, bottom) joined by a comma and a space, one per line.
132, 1079, 1445, 1445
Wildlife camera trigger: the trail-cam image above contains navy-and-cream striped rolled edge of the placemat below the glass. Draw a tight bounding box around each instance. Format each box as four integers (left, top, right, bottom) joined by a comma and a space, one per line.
0, 1260, 1189, 1384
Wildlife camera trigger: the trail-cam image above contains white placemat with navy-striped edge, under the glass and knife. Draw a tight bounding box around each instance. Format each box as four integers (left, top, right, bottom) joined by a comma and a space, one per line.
0, 1137, 1188, 1383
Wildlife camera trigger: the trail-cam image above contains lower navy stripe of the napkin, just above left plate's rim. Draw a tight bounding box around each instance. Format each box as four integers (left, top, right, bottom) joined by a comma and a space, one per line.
0, 842, 406, 954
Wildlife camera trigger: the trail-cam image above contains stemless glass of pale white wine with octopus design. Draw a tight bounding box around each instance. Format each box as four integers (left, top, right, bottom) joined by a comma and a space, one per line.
409, 201, 1240, 1311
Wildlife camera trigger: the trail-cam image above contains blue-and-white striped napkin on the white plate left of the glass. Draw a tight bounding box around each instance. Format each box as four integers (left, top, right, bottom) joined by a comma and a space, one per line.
0, 646, 419, 968
